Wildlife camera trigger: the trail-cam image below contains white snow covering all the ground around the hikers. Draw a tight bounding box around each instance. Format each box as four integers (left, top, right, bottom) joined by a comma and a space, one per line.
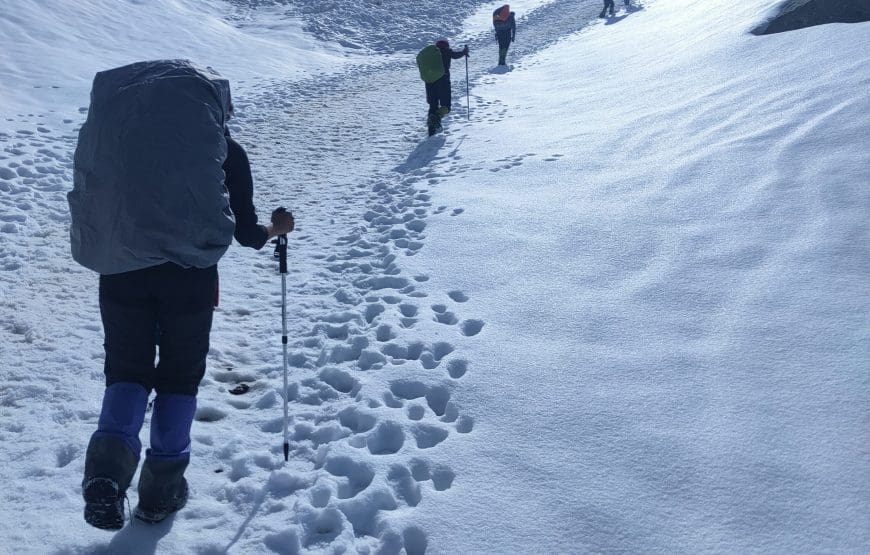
0, 0, 870, 555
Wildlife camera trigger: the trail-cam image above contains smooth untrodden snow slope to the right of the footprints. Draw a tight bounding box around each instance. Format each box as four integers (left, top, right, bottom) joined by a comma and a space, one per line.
409, 2, 870, 553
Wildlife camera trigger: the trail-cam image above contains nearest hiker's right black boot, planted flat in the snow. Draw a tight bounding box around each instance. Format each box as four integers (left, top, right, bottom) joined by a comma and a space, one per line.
133, 454, 190, 524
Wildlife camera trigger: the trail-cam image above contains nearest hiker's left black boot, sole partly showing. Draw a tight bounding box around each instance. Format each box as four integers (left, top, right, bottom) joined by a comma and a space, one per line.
82, 434, 139, 530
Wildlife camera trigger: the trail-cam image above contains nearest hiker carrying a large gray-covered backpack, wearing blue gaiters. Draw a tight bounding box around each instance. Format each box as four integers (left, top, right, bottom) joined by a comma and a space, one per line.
68, 60, 294, 530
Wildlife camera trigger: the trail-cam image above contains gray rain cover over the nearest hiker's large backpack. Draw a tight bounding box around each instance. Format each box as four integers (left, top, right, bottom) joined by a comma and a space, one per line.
67, 60, 235, 274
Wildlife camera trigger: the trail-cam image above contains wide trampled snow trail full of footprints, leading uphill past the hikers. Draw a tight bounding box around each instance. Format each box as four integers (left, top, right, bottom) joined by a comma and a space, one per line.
0, 2, 612, 553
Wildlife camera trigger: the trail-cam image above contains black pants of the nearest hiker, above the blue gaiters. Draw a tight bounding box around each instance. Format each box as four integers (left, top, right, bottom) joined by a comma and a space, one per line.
100, 263, 217, 395
